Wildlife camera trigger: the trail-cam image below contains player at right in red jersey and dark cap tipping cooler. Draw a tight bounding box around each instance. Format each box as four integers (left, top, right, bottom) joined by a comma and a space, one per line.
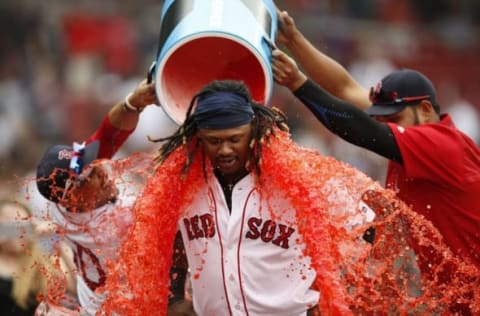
272, 39, 480, 315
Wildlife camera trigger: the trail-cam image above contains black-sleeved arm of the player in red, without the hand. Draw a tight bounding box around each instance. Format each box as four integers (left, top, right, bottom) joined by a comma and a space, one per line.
294, 80, 402, 162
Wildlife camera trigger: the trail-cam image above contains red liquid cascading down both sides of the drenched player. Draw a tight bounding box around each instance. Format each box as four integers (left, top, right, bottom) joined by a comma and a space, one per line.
15, 131, 480, 315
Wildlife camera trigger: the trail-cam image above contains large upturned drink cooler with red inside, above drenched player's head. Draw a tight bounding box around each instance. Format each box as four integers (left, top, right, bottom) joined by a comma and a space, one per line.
153, 0, 277, 124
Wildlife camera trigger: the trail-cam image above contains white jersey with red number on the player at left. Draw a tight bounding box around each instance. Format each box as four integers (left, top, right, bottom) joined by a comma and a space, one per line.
50, 189, 134, 315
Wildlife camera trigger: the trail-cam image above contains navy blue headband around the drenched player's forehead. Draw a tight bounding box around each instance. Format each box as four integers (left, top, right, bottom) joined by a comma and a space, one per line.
195, 91, 254, 129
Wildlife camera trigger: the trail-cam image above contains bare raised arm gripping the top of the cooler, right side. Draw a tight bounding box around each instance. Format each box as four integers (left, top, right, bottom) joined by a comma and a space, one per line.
277, 10, 370, 110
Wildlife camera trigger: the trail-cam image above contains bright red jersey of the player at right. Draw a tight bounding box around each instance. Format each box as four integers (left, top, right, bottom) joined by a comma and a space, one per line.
386, 115, 480, 267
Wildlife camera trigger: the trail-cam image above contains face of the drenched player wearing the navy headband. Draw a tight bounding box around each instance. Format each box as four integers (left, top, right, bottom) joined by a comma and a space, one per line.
198, 123, 252, 177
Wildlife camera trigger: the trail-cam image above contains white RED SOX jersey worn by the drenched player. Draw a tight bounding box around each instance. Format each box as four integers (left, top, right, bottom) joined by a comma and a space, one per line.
178, 169, 372, 316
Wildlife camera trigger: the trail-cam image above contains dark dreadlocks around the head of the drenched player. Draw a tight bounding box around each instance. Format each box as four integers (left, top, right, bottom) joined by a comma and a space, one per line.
150, 80, 288, 177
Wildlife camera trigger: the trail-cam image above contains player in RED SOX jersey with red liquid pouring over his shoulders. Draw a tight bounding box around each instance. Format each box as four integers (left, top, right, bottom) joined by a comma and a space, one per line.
105, 81, 386, 316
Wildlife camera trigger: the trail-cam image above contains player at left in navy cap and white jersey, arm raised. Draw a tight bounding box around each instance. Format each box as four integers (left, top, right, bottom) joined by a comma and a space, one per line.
36, 82, 157, 315
